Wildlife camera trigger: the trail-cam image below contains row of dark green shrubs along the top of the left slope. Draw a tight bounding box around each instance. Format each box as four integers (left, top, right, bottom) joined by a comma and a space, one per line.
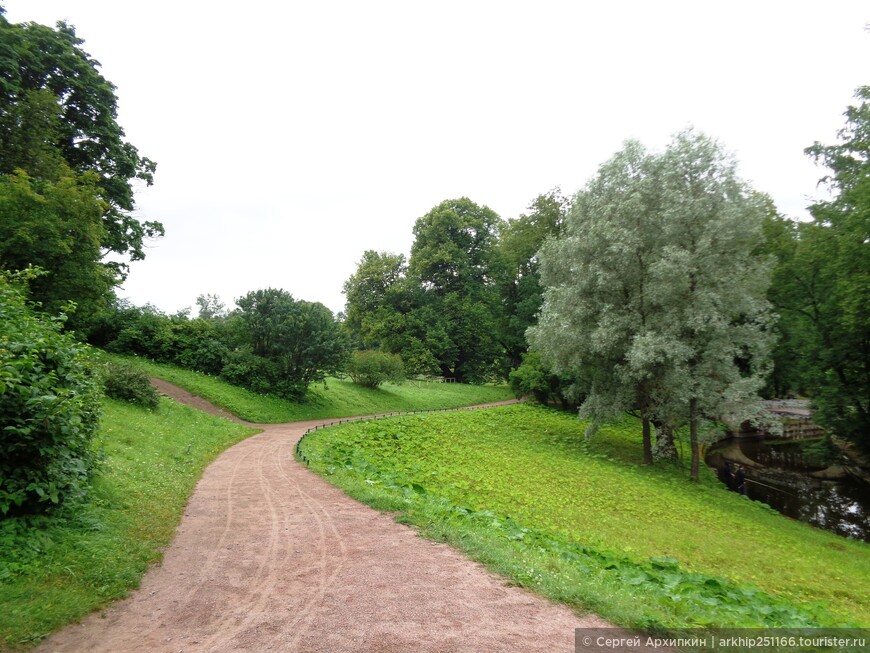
88, 288, 348, 400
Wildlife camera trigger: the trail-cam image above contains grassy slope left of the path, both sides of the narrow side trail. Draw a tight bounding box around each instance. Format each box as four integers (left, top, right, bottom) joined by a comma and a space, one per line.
0, 362, 509, 649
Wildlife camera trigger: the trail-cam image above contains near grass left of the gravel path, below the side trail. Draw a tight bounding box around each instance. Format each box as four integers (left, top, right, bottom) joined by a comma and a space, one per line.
0, 399, 256, 649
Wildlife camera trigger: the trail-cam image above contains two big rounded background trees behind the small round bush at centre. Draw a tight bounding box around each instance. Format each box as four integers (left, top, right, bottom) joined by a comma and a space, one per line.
344, 198, 504, 382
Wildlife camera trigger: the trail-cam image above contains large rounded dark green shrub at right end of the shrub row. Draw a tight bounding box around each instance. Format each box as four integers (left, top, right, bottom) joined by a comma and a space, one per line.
228, 288, 347, 398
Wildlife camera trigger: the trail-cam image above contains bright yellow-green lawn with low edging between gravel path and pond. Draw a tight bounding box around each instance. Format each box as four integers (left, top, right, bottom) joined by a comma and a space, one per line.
302, 406, 870, 629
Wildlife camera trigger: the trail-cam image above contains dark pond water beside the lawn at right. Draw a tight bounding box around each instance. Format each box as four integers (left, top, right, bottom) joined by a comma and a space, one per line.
707, 438, 870, 542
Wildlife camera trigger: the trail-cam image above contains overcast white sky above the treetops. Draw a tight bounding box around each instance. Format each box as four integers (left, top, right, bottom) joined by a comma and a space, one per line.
6, 0, 870, 312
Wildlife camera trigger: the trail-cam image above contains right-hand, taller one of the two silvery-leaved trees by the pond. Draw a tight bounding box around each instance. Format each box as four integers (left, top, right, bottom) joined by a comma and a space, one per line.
656, 131, 773, 480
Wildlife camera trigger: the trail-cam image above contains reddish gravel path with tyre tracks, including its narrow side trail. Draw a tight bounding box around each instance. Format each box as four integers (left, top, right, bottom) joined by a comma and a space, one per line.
38, 382, 608, 653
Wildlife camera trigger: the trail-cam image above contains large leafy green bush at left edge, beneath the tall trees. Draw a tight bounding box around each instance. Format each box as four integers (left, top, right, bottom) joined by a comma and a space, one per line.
0, 275, 99, 515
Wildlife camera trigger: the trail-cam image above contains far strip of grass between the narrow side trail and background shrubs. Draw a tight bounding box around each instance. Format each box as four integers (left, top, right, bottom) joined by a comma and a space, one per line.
110, 356, 513, 424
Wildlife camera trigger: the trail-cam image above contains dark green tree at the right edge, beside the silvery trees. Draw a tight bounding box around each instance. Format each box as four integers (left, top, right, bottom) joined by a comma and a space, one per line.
777, 86, 870, 450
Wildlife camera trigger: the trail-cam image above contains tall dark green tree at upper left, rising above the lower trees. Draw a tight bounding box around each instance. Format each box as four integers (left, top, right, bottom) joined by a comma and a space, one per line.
0, 13, 163, 276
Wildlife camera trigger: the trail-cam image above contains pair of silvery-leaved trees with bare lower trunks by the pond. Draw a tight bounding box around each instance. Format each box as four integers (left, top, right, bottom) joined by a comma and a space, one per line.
528, 130, 773, 480
